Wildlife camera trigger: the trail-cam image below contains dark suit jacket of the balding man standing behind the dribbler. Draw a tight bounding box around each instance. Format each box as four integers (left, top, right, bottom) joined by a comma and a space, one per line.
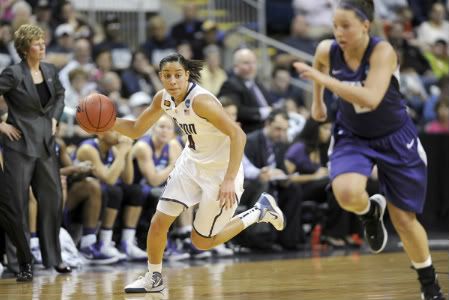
218, 75, 272, 133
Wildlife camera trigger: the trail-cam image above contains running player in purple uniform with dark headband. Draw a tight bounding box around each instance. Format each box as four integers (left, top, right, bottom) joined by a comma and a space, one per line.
294, 0, 444, 299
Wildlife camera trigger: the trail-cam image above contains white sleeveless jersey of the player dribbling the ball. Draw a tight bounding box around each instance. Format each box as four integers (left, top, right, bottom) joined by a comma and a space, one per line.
161, 83, 230, 169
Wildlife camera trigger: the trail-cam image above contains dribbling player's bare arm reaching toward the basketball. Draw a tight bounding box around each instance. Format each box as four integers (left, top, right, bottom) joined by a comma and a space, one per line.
111, 91, 164, 139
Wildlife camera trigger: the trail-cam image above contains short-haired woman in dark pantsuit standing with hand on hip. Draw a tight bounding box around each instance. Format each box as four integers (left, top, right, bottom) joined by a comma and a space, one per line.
0, 24, 71, 281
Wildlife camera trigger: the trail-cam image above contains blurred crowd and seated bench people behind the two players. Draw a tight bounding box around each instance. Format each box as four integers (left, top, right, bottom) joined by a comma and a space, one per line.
0, 0, 449, 270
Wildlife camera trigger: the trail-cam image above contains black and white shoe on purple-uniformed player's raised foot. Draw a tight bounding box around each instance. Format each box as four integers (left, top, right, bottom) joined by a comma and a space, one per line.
360, 194, 388, 253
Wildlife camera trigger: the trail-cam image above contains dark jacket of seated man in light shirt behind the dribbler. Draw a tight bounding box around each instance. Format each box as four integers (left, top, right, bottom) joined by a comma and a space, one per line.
245, 129, 288, 171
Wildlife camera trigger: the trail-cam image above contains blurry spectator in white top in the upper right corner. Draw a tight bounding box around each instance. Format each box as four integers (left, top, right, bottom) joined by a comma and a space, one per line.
417, 3, 449, 50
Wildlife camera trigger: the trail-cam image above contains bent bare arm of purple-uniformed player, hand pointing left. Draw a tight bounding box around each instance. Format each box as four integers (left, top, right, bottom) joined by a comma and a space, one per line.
294, 42, 397, 110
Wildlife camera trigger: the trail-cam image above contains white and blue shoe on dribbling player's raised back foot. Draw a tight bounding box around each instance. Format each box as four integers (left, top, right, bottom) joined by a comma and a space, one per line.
254, 193, 286, 231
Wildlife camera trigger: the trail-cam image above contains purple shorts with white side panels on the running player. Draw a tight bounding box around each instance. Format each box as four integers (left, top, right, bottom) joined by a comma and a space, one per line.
329, 120, 427, 213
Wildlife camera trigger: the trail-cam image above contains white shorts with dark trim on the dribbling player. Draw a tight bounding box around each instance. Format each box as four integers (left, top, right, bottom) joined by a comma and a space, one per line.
157, 156, 244, 237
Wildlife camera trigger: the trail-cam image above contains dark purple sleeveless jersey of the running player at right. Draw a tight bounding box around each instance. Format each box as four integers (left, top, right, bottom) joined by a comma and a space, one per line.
329, 37, 409, 138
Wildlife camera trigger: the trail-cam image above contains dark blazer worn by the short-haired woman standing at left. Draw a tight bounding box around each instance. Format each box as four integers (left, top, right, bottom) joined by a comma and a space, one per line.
0, 61, 64, 157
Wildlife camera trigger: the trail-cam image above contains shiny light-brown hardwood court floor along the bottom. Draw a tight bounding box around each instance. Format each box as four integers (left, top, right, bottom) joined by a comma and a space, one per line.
0, 251, 448, 300
